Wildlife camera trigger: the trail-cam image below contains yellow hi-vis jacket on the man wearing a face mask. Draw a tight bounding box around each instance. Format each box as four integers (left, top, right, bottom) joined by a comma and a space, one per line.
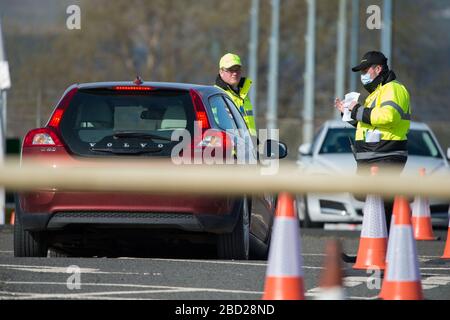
352, 73, 411, 161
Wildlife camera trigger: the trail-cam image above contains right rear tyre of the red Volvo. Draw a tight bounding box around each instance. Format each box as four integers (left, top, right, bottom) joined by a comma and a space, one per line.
217, 198, 250, 260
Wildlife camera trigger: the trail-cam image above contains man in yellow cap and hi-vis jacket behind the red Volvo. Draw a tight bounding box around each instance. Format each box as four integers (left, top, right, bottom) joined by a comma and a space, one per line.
216, 53, 256, 136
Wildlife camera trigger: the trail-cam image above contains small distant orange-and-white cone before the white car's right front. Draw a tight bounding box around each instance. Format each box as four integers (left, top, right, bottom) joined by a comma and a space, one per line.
412, 168, 436, 240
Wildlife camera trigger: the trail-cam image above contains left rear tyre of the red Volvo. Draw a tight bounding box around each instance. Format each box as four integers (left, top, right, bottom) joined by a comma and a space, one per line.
14, 214, 48, 257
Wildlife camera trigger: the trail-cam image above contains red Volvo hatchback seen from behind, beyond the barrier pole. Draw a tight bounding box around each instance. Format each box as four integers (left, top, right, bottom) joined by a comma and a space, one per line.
14, 79, 287, 259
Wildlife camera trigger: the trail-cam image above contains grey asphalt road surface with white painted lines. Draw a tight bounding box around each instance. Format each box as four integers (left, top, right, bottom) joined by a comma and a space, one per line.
0, 226, 450, 300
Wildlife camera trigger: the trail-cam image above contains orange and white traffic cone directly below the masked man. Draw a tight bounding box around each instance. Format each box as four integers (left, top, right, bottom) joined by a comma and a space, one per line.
353, 167, 387, 270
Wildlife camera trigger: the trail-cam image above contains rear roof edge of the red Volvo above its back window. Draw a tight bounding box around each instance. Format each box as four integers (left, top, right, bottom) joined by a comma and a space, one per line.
74, 81, 223, 95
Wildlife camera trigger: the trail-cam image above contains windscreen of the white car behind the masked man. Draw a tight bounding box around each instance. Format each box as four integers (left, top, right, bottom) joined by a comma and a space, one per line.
319, 128, 442, 158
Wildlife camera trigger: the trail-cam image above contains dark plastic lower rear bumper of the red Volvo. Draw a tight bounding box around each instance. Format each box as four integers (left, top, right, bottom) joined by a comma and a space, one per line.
16, 197, 242, 234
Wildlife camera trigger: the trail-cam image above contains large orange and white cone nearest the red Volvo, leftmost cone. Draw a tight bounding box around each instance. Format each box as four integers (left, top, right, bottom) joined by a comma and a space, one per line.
263, 192, 305, 300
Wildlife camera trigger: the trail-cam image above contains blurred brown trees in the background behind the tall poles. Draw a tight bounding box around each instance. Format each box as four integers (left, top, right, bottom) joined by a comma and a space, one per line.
3, 0, 450, 157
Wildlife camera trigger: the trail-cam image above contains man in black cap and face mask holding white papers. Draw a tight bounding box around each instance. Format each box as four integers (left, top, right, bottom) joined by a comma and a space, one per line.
335, 51, 411, 232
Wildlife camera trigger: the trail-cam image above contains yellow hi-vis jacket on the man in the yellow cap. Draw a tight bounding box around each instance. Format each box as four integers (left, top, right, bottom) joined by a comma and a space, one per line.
215, 75, 256, 136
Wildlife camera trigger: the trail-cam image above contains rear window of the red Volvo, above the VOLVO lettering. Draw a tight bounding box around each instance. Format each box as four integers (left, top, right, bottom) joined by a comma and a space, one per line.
60, 89, 194, 156
